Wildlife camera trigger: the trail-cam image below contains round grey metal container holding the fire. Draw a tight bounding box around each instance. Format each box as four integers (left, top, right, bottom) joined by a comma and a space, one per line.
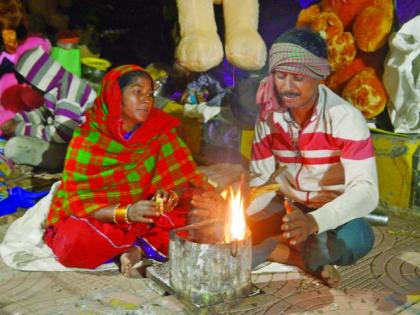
169, 221, 252, 308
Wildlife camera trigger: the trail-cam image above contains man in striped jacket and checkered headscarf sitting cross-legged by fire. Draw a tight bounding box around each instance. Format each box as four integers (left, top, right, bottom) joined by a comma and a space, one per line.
193, 29, 378, 286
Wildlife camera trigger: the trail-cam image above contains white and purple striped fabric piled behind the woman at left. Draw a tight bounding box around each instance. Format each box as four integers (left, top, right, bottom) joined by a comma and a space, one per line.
14, 47, 96, 143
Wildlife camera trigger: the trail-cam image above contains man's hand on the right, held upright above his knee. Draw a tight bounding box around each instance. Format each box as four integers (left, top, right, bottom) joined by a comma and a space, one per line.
281, 200, 318, 245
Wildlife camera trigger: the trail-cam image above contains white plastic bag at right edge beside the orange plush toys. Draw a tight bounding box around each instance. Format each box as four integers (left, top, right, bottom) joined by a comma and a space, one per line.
383, 16, 420, 133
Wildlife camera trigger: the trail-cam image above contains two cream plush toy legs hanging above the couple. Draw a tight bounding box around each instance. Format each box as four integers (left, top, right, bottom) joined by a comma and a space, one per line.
175, 0, 267, 72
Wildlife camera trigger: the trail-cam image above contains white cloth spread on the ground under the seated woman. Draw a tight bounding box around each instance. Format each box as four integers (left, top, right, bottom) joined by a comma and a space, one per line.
0, 182, 117, 271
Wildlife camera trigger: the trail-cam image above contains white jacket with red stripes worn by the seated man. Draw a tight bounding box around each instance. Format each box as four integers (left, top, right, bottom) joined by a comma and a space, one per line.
250, 85, 379, 233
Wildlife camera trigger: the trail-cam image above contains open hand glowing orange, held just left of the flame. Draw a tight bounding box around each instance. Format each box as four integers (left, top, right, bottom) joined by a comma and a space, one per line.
191, 191, 227, 220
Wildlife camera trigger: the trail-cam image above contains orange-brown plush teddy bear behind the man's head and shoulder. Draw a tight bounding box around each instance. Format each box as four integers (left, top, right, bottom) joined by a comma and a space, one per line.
296, 0, 393, 119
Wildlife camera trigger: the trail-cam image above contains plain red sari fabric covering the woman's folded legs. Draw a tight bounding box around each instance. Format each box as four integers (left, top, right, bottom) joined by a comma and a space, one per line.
44, 198, 188, 269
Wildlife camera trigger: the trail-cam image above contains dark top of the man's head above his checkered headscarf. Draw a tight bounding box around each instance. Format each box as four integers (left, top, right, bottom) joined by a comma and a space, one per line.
273, 28, 328, 59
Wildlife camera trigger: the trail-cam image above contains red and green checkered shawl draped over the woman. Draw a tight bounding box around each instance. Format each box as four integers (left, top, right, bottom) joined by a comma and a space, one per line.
48, 66, 209, 225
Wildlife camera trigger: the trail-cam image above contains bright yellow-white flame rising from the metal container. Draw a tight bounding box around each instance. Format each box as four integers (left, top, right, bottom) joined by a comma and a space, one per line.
225, 187, 246, 243
